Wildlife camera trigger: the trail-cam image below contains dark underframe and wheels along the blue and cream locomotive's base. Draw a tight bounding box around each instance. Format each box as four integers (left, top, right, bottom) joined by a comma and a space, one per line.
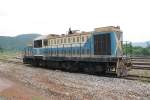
23, 56, 131, 77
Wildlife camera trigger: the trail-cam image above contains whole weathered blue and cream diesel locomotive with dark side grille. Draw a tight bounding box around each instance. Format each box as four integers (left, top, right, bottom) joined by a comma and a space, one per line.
23, 26, 131, 76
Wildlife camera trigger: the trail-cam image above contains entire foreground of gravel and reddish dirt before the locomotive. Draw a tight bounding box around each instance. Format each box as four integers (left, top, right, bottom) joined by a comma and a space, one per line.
0, 60, 150, 100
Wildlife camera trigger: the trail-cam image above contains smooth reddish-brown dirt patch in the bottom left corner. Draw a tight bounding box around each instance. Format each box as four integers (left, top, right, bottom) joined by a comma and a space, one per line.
0, 75, 48, 100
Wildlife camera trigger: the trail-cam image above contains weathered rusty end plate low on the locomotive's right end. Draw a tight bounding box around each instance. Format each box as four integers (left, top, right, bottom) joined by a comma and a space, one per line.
116, 60, 128, 77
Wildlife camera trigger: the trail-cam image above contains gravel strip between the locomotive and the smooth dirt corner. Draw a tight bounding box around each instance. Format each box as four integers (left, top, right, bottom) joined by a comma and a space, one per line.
0, 61, 150, 100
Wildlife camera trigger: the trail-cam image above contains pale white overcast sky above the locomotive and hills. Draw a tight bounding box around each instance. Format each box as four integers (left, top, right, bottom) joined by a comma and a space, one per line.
0, 0, 150, 42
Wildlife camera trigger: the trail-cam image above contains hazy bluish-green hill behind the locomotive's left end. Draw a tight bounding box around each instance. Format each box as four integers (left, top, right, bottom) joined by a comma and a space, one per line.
0, 34, 40, 50
